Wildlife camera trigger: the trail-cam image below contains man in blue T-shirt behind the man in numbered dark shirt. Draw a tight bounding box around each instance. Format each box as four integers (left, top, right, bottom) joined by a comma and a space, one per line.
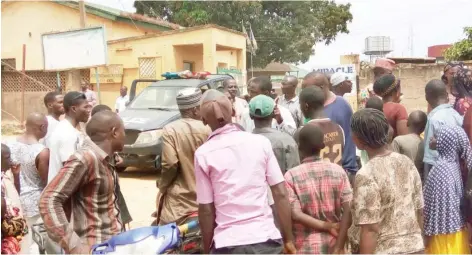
302, 72, 358, 183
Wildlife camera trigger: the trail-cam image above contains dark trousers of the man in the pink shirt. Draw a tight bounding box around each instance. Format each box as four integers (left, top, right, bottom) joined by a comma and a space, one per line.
211, 239, 283, 254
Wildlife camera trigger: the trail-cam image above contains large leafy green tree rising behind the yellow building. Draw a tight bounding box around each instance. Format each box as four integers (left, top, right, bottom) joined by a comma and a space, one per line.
134, 1, 352, 67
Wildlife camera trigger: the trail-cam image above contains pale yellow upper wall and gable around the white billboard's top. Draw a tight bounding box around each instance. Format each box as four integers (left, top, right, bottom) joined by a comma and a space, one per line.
2, 1, 155, 70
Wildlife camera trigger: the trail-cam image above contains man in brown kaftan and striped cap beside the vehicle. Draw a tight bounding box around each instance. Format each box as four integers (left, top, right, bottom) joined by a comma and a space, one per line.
157, 88, 211, 229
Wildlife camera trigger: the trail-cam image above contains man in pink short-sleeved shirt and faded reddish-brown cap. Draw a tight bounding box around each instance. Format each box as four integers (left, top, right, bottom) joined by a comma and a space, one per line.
195, 90, 296, 254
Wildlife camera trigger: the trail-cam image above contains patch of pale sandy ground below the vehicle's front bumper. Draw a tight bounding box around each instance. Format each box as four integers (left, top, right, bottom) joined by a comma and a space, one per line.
1, 135, 159, 228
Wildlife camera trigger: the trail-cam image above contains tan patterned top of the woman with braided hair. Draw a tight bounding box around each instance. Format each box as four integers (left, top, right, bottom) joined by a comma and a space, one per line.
349, 152, 424, 254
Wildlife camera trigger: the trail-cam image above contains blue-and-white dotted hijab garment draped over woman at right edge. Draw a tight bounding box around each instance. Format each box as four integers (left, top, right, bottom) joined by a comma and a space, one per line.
424, 126, 472, 236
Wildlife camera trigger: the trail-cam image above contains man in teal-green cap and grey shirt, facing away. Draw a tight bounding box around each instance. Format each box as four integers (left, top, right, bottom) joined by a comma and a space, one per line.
249, 95, 300, 174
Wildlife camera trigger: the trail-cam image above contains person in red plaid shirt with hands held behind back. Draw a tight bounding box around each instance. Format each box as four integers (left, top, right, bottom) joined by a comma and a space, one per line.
285, 125, 352, 254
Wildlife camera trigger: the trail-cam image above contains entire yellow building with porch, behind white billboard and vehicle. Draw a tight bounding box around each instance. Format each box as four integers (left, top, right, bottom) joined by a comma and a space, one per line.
1, 1, 246, 119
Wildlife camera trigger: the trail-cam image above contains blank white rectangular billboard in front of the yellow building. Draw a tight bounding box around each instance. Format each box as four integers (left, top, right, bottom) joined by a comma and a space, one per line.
42, 27, 108, 71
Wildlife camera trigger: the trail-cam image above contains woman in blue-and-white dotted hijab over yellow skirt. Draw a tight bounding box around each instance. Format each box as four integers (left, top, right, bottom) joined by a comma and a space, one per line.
424, 125, 472, 254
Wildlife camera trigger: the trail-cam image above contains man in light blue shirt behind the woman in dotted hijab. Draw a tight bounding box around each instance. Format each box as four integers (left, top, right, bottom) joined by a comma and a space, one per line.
423, 79, 463, 181
